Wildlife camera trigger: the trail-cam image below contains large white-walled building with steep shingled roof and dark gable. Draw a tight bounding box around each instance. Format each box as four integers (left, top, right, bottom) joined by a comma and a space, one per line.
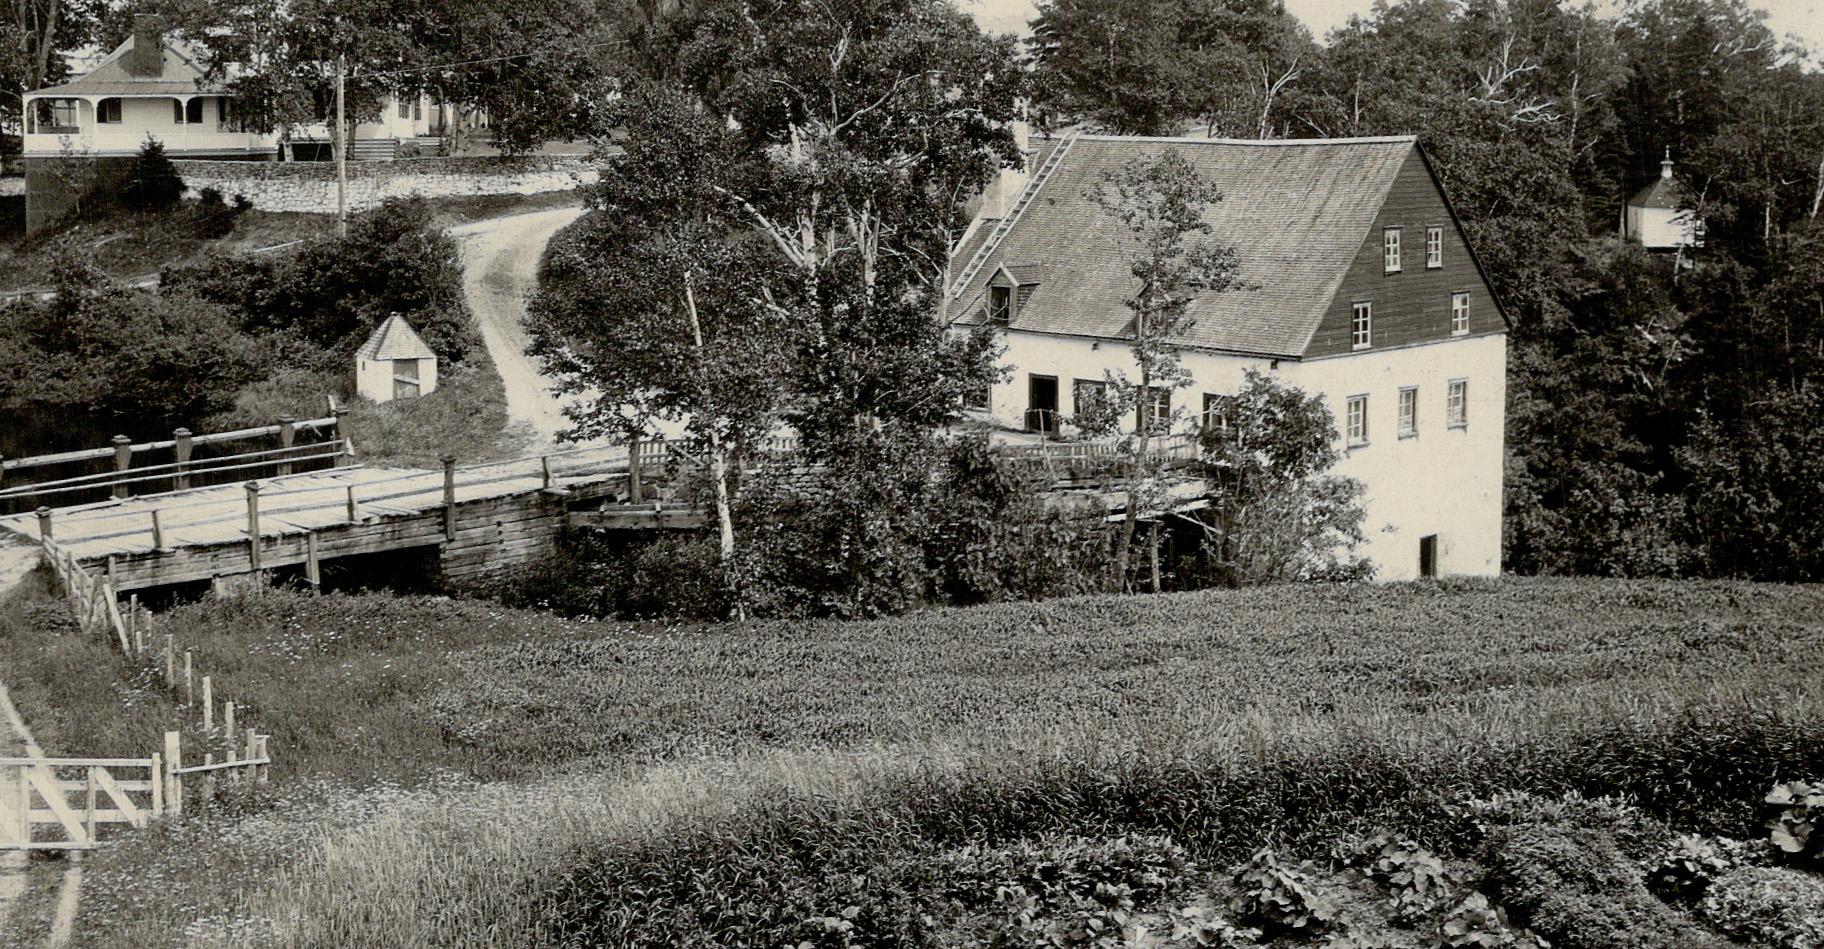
948, 135, 1507, 580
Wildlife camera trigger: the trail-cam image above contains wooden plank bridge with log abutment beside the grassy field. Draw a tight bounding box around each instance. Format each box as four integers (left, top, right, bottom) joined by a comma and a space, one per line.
0, 442, 702, 593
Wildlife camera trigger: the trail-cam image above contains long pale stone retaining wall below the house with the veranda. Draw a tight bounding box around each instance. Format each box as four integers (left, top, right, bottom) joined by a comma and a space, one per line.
171, 155, 598, 214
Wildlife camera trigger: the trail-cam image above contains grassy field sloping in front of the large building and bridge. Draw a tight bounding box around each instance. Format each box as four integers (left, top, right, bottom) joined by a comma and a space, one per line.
0, 580, 1824, 945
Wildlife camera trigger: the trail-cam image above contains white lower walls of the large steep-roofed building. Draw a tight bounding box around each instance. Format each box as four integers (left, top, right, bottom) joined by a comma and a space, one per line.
990, 332, 1507, 580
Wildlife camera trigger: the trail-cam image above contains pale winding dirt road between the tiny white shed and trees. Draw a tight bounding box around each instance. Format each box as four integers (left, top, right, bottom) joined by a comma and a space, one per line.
451, 208, 582, 447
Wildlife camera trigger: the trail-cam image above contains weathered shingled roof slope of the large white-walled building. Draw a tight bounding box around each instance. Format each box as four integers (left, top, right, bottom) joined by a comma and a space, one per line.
956, 135, 1417, 356
